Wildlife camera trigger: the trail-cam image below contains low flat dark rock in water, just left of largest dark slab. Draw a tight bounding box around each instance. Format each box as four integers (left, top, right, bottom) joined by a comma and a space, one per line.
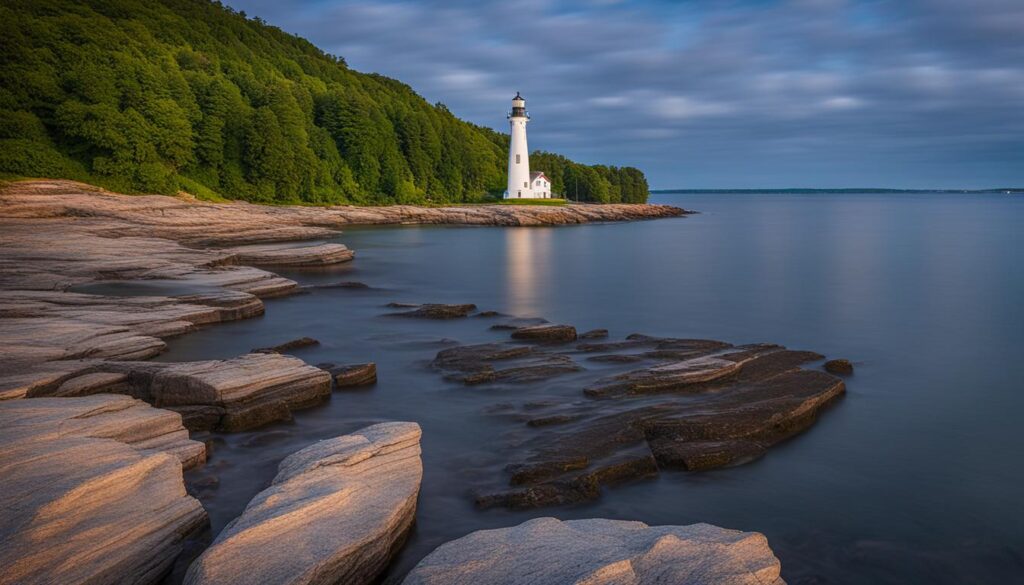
433, 343, 582, 385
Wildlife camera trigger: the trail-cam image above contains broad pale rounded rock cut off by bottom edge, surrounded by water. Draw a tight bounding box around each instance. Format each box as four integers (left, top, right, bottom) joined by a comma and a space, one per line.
402, 518, 785, 585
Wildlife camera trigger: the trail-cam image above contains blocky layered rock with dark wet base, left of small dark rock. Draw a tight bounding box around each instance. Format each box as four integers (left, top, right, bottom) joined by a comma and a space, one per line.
102, 353, 331, 431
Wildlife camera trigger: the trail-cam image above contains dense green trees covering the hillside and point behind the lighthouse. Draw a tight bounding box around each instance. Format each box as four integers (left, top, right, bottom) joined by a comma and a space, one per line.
0, 0, 647, 204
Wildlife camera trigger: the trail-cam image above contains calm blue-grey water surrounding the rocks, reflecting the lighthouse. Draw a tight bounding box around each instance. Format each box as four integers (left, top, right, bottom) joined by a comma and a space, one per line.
162, 195, 1024, 584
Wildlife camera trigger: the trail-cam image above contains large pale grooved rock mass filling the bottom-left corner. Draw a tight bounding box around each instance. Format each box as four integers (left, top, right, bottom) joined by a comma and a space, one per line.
0, 394, 206, 585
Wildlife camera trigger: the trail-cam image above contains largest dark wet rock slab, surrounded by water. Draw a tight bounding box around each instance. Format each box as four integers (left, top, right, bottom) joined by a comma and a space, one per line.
476, 337, 845, 508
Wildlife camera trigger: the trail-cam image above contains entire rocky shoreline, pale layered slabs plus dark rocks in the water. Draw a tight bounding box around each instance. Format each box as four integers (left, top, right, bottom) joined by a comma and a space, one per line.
0, 181, 845, 584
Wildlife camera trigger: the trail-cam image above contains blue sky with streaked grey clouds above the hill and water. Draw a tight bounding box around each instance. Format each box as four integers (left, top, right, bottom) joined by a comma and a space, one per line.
226, 0, 1024, 189
